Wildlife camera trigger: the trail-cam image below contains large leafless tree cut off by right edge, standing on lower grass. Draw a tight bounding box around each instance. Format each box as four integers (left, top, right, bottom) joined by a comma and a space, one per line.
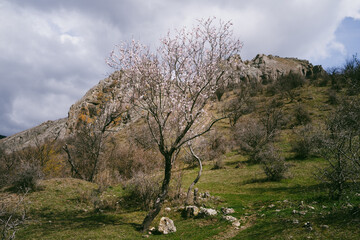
318, 100, 360, 199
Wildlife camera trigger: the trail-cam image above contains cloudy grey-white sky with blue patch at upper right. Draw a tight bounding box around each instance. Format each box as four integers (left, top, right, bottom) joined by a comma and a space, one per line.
0, 0, 360, 136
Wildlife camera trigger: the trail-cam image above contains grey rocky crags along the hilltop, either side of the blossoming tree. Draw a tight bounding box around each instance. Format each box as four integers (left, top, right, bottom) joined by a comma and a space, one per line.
0, 54, 325, 151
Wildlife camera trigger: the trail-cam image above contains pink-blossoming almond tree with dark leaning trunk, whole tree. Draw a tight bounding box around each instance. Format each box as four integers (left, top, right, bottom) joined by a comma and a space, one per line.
108, 18, 242, 231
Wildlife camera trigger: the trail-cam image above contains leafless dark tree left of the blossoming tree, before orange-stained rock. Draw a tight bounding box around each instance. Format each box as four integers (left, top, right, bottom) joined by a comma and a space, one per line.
63, 88, 128, 182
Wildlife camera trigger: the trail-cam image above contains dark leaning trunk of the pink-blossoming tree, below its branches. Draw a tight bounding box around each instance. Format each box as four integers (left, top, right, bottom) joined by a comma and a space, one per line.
141, 154, 172, 232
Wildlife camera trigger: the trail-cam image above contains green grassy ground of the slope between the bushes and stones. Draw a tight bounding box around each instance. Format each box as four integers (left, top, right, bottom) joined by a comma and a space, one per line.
0, 62, 360, 239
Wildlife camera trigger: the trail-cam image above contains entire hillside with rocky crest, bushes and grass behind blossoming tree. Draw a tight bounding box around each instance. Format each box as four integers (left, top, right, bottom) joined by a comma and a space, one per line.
0, 52, 360, 239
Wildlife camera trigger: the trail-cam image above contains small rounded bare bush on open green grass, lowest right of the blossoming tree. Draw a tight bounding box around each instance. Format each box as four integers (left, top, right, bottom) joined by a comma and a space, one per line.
257, 145, 288, 181
